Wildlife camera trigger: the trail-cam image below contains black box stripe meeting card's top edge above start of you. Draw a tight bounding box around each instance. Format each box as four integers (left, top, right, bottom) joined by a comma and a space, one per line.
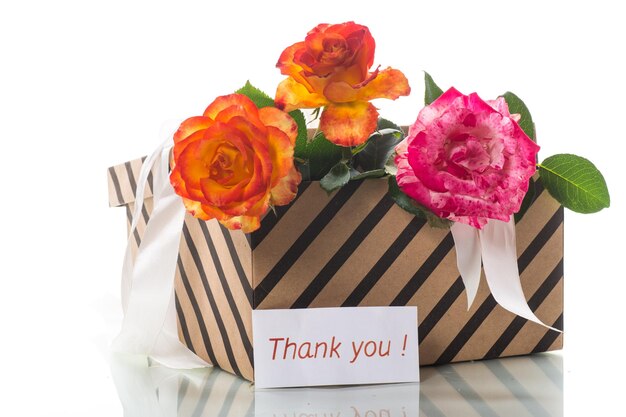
341, 217, 426, 307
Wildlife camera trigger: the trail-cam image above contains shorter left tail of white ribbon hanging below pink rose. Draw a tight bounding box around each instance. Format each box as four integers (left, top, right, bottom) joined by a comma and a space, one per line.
450, 222, 481, 310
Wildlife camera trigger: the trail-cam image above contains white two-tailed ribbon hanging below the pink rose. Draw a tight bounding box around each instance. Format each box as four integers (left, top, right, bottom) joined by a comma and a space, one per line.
450, 216, 560, 332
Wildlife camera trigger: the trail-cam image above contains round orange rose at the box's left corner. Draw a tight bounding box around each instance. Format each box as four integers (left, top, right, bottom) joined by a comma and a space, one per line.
170, 94, 301, 233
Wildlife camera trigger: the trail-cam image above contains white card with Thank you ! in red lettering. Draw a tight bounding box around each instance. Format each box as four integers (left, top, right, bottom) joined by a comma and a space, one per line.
252, 307, 419, 388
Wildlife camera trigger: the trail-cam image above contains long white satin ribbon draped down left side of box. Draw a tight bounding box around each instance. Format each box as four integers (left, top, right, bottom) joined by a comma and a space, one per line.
112, 135, 210, 369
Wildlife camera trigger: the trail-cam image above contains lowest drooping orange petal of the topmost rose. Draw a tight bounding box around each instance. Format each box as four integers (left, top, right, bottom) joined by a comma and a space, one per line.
320, 101, 378, 146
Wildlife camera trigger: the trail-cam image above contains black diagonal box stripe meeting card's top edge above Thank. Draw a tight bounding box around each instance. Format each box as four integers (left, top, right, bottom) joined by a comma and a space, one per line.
291, 194, 394, 308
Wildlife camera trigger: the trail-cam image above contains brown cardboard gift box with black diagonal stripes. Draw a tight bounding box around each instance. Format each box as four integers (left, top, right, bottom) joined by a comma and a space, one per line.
109, 154, 563, 380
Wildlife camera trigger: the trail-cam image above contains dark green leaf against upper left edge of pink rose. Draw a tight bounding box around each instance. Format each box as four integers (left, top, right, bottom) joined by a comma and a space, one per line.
358, 118, 404, 171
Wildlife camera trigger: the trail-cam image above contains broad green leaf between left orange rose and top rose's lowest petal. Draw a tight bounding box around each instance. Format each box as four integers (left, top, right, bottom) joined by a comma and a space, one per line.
298, 132, 343, 181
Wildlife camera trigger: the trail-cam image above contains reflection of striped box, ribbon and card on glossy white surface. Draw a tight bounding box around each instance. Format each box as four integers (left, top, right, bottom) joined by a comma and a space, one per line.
112, 354, 563, 417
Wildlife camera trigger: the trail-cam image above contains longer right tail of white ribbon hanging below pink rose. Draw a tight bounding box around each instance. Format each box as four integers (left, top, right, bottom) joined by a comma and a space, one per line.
479, 216, 561, 332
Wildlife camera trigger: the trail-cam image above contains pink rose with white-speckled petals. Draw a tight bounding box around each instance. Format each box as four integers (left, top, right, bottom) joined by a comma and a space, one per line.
395, 88, 539, 229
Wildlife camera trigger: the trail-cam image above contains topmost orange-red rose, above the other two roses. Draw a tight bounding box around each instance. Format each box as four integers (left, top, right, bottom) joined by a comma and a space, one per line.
276, 22, 411, 146
